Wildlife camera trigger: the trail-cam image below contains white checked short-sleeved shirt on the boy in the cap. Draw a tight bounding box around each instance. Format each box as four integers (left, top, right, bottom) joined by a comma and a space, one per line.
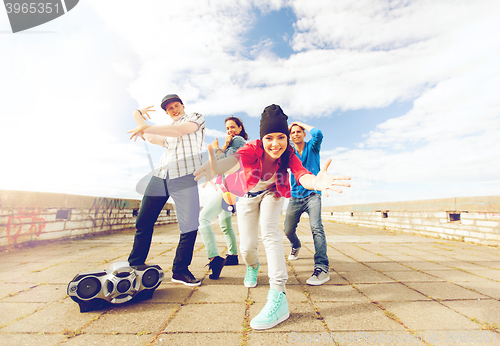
154, 113, 205, 179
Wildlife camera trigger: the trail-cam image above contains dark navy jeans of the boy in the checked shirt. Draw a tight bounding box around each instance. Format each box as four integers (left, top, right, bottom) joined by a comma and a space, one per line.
128, 174, 200, 272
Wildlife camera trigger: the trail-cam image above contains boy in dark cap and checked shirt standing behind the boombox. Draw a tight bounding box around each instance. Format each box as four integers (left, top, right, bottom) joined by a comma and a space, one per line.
128, 94, 205, 286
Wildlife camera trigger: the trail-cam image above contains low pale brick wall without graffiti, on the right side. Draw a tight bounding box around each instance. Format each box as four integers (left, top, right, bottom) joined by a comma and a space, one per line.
322, 196, 500, 245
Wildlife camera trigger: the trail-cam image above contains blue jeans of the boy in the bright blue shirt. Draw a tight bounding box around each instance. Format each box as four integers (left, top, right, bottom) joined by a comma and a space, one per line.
285, 193, 330, 272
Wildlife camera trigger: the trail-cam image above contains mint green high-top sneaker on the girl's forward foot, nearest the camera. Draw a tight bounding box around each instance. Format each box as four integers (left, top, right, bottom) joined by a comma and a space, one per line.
250, 288, 290, 329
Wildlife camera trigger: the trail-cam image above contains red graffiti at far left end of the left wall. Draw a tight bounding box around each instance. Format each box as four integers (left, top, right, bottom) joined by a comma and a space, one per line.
7, 208, 45, 243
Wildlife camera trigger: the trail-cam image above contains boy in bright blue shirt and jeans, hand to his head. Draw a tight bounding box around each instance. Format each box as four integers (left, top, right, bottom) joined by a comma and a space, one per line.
285, 121, 330, 285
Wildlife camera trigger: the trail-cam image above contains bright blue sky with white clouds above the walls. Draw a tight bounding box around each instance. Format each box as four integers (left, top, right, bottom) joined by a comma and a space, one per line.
0, 0, 500, 206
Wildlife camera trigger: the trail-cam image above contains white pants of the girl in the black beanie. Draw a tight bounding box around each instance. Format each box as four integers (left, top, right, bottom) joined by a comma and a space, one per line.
236, 192, 288, 292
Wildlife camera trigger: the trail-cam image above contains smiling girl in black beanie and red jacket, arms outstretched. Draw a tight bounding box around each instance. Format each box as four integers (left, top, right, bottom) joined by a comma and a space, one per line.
194, 105, 350, 329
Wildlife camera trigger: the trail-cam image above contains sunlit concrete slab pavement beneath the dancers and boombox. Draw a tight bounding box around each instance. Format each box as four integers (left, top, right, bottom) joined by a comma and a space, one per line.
0, 218, 500, 346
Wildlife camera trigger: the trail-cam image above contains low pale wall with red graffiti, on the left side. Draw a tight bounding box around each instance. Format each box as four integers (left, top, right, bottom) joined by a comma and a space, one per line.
0, 190, 177, 248
